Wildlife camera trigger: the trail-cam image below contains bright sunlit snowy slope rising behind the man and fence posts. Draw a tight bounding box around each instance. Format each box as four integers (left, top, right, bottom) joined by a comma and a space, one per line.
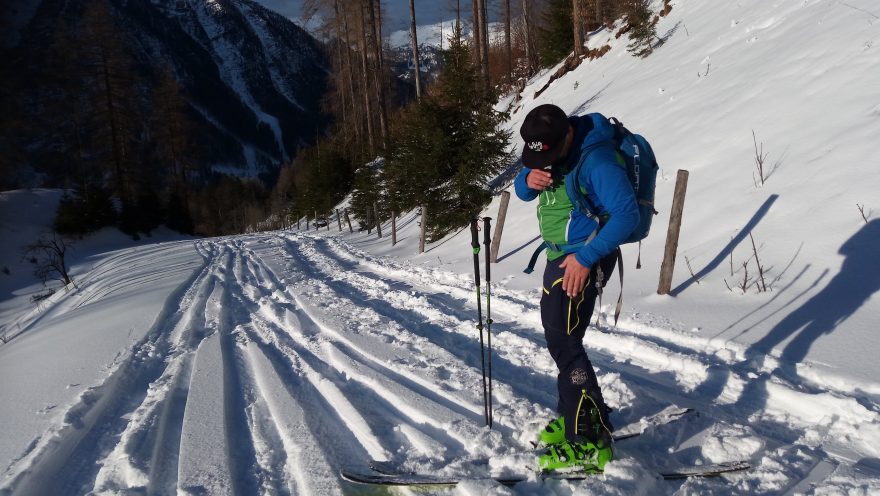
490, 1, 880, 381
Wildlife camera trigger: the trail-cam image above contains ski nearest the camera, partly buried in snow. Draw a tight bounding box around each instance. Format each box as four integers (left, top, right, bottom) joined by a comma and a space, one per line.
340, 460, 752, 486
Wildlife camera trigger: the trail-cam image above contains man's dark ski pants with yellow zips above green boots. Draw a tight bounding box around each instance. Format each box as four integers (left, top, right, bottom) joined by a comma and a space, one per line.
541, 250, 617, 441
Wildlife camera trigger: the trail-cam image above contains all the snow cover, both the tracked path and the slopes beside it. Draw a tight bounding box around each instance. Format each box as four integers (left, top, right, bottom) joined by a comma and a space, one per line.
0, 0, 880, 495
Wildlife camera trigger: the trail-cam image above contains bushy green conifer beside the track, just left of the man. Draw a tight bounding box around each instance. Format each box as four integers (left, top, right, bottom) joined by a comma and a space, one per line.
376, 26, 510, 240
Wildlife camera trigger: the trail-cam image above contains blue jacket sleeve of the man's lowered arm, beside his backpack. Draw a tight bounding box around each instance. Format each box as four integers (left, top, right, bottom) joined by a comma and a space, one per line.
575, 162, 639, 267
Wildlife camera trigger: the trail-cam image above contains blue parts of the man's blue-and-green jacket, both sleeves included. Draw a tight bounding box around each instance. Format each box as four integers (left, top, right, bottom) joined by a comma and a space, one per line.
514, 113, 639, 267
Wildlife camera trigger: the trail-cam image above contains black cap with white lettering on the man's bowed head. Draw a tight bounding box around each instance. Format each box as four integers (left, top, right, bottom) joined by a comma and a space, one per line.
519, 103, 569, 169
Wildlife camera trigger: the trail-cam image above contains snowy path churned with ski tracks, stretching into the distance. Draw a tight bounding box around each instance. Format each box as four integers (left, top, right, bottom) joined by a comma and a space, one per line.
0, 232, 880, 495
